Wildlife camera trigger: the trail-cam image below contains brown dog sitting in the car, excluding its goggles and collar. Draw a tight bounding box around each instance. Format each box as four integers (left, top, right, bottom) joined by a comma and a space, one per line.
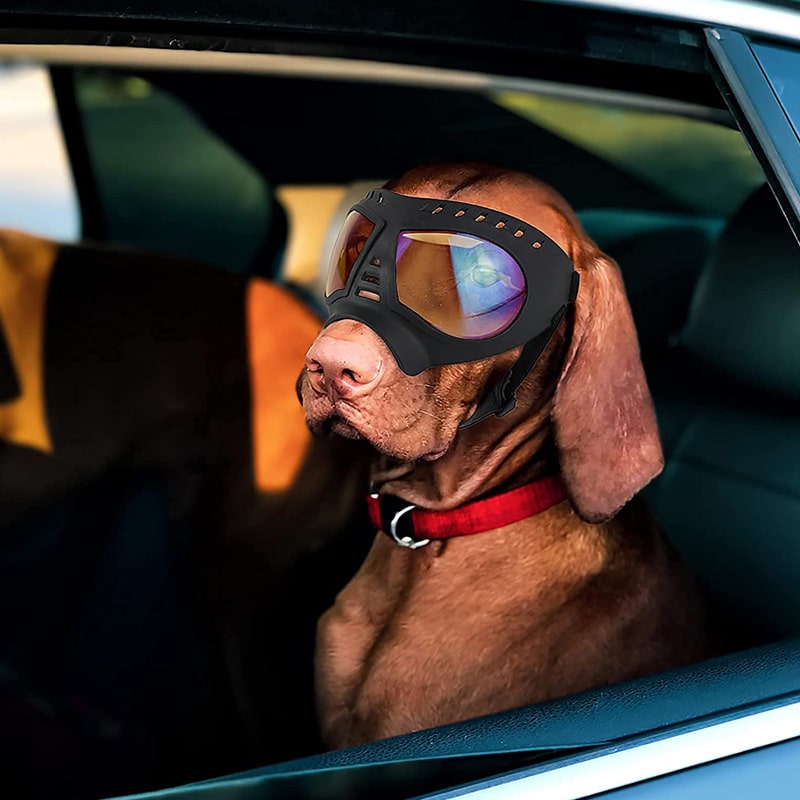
299, 164, 707, 747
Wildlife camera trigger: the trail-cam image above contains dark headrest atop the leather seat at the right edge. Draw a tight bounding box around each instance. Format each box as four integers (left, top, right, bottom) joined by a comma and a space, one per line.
680, 184, 800, 398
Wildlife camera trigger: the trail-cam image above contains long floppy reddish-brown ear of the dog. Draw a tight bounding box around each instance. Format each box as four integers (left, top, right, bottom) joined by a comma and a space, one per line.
552, 248, 664, 522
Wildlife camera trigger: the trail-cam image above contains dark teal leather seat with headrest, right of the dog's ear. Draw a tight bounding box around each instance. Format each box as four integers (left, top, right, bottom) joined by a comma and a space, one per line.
645, 186, 800, 638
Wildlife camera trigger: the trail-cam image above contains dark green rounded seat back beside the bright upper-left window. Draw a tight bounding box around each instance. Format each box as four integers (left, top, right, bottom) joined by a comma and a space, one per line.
70, 70, 286, 278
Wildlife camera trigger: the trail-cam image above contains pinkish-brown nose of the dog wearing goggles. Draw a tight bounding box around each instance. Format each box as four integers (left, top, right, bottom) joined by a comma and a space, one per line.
306, 334, 383, 399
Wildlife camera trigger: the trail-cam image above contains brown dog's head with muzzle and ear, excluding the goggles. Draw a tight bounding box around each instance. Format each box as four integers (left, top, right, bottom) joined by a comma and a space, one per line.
298, 164, 663, 522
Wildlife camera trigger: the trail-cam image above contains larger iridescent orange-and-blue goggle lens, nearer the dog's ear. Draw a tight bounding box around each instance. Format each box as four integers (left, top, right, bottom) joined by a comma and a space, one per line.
396, 231, 525, 339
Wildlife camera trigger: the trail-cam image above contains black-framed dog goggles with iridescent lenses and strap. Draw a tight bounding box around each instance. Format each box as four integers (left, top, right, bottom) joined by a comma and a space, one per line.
325, 189, 578, 424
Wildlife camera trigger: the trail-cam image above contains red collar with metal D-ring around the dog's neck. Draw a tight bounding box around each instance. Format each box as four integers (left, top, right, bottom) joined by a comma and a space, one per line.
367, 475, 567, 550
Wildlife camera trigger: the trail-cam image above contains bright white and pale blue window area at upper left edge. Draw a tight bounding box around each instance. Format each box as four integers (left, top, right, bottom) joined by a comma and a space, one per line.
0, 63, 80, 241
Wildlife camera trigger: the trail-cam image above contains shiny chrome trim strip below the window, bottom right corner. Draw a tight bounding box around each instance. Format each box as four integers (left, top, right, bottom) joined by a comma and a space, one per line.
446, 701, 800, 800
